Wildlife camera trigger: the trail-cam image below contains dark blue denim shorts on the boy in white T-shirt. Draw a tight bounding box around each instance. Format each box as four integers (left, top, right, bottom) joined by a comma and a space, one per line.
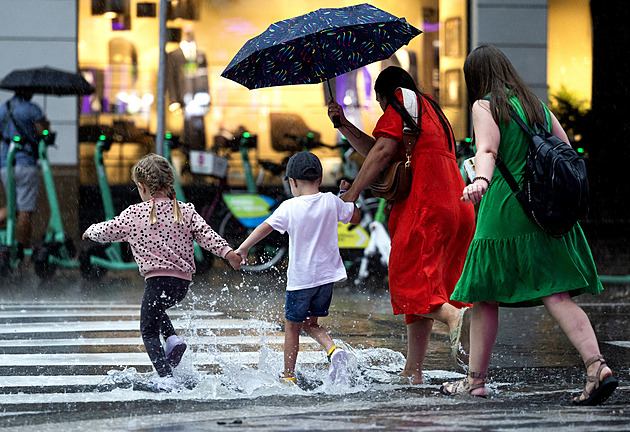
284, 282, 334, 322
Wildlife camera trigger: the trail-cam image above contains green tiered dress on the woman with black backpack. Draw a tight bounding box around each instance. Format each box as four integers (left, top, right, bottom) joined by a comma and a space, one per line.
451, 98, 603, 307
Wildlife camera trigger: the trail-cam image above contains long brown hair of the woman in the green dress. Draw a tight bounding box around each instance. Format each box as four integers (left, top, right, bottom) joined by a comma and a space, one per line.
464, 45, 544, 125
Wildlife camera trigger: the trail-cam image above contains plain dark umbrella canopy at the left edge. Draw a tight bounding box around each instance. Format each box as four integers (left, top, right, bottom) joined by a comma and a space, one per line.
0, 67, 94, 96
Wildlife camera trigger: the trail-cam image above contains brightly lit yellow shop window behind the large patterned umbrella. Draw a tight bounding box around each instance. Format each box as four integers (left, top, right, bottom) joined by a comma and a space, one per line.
79, 0, 467, 184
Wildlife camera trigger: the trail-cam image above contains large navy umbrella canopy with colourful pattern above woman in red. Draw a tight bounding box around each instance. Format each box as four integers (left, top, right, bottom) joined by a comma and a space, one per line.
221, 4, 422, 89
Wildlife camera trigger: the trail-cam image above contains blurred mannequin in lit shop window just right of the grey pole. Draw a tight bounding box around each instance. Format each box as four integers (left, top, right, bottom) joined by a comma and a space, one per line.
166, 26, 210, 150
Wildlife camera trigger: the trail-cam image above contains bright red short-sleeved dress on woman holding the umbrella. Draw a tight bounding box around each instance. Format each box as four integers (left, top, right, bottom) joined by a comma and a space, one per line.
373, 92, 475, 324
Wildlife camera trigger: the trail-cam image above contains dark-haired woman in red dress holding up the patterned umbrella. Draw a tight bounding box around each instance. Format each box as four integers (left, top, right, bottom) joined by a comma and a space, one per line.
328, 66, 475, 384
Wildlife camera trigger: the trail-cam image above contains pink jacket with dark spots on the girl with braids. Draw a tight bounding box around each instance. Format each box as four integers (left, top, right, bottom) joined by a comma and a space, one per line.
86, 198, 232, 280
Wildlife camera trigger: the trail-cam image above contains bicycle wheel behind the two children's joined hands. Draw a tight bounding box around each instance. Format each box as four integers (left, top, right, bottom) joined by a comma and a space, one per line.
219, 212, 289, 272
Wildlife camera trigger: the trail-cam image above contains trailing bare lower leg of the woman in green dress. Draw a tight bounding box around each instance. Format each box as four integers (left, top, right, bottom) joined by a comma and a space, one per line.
542, 293, 612, 402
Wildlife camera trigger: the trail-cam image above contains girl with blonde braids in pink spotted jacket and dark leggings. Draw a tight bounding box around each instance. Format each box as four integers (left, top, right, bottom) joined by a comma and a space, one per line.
83, 154, 241, 390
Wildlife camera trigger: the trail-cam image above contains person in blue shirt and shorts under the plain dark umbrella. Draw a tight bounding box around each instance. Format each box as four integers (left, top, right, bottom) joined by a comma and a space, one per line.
0, 89, 48, 248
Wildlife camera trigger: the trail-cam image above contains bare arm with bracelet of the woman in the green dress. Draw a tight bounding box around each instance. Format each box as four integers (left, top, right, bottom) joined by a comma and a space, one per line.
462, 100, 501, 204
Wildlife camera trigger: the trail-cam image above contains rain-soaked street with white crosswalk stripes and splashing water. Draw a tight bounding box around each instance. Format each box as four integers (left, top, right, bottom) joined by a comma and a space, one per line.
0, 263, 630, 431
